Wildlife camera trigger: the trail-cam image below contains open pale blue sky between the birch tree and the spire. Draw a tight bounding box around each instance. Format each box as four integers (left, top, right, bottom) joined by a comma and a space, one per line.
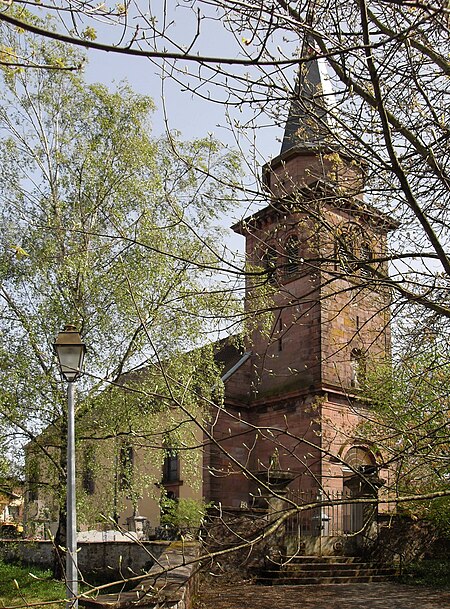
77, 0, 291, 229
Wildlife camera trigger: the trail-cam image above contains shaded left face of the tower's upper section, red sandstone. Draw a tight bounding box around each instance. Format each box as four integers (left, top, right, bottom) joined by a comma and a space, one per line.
246, 212, 320, 400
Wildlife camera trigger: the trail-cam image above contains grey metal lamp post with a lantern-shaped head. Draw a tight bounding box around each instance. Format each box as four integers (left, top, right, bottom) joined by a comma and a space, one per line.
53, 325, 86, 609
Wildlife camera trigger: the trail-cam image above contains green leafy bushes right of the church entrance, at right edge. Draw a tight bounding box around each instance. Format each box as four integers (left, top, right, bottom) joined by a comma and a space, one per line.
361, 341, 450, 531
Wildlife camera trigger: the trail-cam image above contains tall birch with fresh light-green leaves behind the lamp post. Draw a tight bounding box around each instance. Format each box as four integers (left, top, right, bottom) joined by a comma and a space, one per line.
0, 28, 243, 568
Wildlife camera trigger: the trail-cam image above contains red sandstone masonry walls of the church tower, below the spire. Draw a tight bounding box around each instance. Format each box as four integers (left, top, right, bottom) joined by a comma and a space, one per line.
205, 155, 390, 507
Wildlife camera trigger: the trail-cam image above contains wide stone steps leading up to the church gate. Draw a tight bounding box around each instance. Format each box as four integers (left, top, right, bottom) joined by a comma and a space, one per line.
257, 556, 396, 586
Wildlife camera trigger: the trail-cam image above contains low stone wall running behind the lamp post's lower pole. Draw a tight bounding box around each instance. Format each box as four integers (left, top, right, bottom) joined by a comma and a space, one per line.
0, 539, 170, 579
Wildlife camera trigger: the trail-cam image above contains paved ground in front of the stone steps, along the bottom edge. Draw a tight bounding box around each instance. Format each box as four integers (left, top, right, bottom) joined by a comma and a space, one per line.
196, 582, 450, 609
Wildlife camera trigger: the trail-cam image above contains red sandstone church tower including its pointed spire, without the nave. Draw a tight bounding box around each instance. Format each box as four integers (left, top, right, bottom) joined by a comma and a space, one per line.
206, 52, 394, 507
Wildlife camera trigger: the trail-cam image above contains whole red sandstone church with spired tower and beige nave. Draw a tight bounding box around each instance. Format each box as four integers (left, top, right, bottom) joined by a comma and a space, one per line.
26, 53, 396, 536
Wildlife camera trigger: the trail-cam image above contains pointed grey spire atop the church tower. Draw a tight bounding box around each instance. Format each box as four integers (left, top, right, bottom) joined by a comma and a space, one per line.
281, 48, 334, 154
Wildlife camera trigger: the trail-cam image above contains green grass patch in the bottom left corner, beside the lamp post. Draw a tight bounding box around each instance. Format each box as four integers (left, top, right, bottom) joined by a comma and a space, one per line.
0, 561, 65, 609
